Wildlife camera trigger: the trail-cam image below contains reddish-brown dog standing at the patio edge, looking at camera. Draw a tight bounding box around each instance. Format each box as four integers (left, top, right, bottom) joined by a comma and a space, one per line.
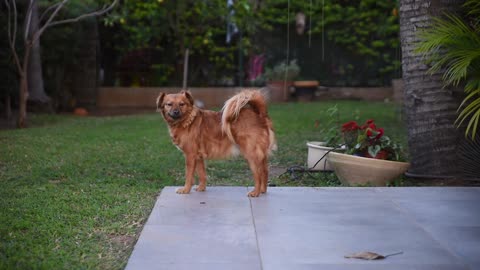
157, 90, 276, 197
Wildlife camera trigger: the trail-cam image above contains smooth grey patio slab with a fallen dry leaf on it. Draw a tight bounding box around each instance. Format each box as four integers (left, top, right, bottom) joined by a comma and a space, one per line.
126, 187, 480, 270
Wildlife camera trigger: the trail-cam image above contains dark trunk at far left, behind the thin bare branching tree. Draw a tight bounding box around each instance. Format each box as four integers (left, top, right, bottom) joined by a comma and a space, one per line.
24, 1, 50, 106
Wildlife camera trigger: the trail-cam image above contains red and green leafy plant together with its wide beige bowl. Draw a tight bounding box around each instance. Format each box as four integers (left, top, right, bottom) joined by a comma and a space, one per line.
329, 120, 410, 186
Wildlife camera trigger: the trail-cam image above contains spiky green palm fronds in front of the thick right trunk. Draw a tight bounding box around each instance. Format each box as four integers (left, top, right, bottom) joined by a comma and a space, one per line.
416, 0, 480, 140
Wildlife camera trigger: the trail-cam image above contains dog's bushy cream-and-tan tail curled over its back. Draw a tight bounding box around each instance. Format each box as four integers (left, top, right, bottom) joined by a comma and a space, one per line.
222, 90, 277, 151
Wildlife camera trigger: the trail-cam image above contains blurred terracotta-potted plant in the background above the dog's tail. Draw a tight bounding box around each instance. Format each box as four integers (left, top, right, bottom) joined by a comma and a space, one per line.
264, 60, 300, 102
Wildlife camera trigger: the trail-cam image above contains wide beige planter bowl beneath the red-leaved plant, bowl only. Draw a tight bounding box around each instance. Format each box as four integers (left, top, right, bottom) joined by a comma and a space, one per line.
328, 152, 410, 186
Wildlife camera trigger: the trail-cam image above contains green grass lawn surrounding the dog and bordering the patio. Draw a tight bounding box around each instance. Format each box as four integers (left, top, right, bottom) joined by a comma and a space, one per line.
0, 101, 406, 269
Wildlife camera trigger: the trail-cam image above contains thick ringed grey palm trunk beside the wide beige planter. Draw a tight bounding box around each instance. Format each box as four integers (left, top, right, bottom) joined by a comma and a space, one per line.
400, 0, 463, 178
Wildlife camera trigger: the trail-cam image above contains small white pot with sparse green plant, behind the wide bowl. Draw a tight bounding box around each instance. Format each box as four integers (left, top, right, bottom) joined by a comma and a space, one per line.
307, 105, 344, 171
